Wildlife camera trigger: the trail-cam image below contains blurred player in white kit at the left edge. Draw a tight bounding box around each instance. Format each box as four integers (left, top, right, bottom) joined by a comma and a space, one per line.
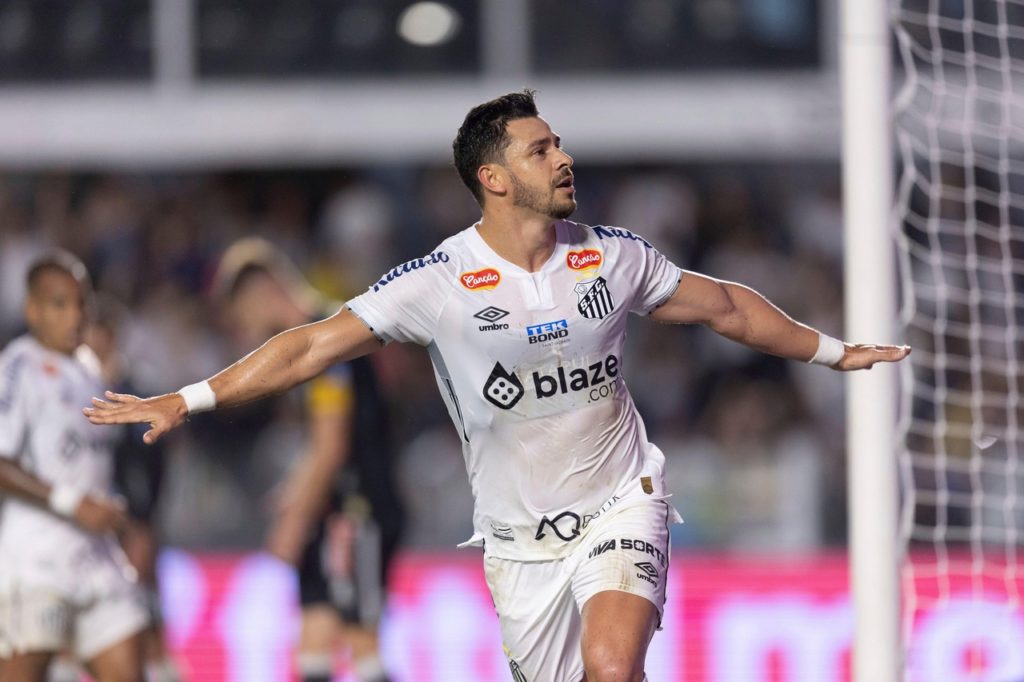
0, 252, 147, 682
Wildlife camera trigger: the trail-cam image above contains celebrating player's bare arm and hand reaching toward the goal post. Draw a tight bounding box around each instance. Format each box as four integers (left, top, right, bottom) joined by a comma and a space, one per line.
651, 272, 910, 371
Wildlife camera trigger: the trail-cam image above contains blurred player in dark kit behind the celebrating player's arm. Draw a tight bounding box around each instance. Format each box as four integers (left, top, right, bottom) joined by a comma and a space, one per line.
213, 238, 402, 682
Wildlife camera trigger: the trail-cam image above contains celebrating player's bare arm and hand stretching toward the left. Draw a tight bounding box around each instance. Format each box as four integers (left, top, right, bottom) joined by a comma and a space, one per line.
83, 308, 380, 443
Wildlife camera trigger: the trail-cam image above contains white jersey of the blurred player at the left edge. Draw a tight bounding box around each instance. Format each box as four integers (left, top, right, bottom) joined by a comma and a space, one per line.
0, 336, 120, 577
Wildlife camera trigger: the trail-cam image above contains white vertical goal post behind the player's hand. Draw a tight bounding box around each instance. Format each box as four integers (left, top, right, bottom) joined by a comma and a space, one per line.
840, 0, 902, 682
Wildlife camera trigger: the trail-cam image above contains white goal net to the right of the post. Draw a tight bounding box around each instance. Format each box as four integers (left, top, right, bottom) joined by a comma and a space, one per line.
892, 0, 1024, 682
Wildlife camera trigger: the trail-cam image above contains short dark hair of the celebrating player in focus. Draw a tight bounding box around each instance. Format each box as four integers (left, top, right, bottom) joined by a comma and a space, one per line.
452, 89, 538, 206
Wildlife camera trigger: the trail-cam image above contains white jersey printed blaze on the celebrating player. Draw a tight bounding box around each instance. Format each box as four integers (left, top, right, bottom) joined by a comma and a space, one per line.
348, 221, 682, 560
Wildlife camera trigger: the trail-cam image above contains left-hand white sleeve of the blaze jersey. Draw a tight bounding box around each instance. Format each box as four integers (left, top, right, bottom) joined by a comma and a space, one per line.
346, 251, 452, 346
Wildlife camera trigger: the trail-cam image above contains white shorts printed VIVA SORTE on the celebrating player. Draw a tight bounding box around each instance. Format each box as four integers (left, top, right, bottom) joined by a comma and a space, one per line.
483, 499, 679, 682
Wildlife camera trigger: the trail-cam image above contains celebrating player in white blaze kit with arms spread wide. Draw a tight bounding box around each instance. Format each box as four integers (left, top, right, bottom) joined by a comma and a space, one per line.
85, 90, 909, 682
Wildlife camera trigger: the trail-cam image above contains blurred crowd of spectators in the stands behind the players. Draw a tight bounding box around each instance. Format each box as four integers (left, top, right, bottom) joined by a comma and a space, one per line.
0, 163, 846, 553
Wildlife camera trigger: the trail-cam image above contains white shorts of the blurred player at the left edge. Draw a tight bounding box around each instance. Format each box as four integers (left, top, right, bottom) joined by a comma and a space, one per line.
0, 540, 150, 662
